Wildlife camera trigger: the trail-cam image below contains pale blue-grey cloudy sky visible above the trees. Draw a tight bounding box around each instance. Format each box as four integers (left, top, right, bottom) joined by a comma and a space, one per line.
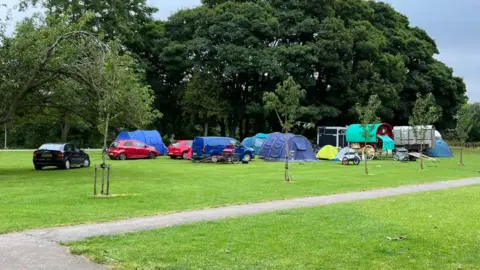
0, 0, 480, 101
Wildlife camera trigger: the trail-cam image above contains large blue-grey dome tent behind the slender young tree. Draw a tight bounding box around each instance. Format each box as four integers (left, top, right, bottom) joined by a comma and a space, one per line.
260, 132, 317, 161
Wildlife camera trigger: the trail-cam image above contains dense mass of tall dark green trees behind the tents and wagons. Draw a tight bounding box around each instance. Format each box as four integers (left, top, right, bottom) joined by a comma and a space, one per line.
0, 0, 467, 148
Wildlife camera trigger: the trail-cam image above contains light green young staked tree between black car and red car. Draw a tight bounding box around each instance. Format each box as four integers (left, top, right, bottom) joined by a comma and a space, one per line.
64, 41, 161, 163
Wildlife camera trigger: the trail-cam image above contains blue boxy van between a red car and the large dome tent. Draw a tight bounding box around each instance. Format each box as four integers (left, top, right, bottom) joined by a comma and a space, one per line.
192, 137, 255, 161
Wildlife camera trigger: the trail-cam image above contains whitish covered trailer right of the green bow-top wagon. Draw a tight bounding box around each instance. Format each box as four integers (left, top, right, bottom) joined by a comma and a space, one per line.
393, 126, 437, 152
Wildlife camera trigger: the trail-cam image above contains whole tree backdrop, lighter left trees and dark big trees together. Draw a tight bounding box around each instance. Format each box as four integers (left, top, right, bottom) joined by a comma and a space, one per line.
0, 0, 475, 147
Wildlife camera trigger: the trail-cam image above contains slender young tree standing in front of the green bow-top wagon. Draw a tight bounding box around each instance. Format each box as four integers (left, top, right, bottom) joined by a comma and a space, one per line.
355, 95, 382, 175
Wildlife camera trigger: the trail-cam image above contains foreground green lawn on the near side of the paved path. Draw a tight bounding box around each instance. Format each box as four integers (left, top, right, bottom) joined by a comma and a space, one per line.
69, 186, 480, 269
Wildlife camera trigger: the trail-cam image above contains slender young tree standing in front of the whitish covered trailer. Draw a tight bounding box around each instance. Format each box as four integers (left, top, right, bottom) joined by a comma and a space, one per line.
409, 93, 439, 170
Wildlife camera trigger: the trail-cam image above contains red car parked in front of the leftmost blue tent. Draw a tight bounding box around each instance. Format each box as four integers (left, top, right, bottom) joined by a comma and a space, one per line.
108, 140, 158, 160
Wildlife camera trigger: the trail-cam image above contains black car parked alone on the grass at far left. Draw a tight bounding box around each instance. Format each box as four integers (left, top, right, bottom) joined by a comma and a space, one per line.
33, 143, 90, 170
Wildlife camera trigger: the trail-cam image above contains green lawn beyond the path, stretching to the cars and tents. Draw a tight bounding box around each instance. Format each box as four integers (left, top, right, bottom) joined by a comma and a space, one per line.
0, 151, 480, 233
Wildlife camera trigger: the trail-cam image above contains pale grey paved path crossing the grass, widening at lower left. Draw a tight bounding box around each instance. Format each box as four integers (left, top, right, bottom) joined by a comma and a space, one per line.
0, 178, 480, 270
